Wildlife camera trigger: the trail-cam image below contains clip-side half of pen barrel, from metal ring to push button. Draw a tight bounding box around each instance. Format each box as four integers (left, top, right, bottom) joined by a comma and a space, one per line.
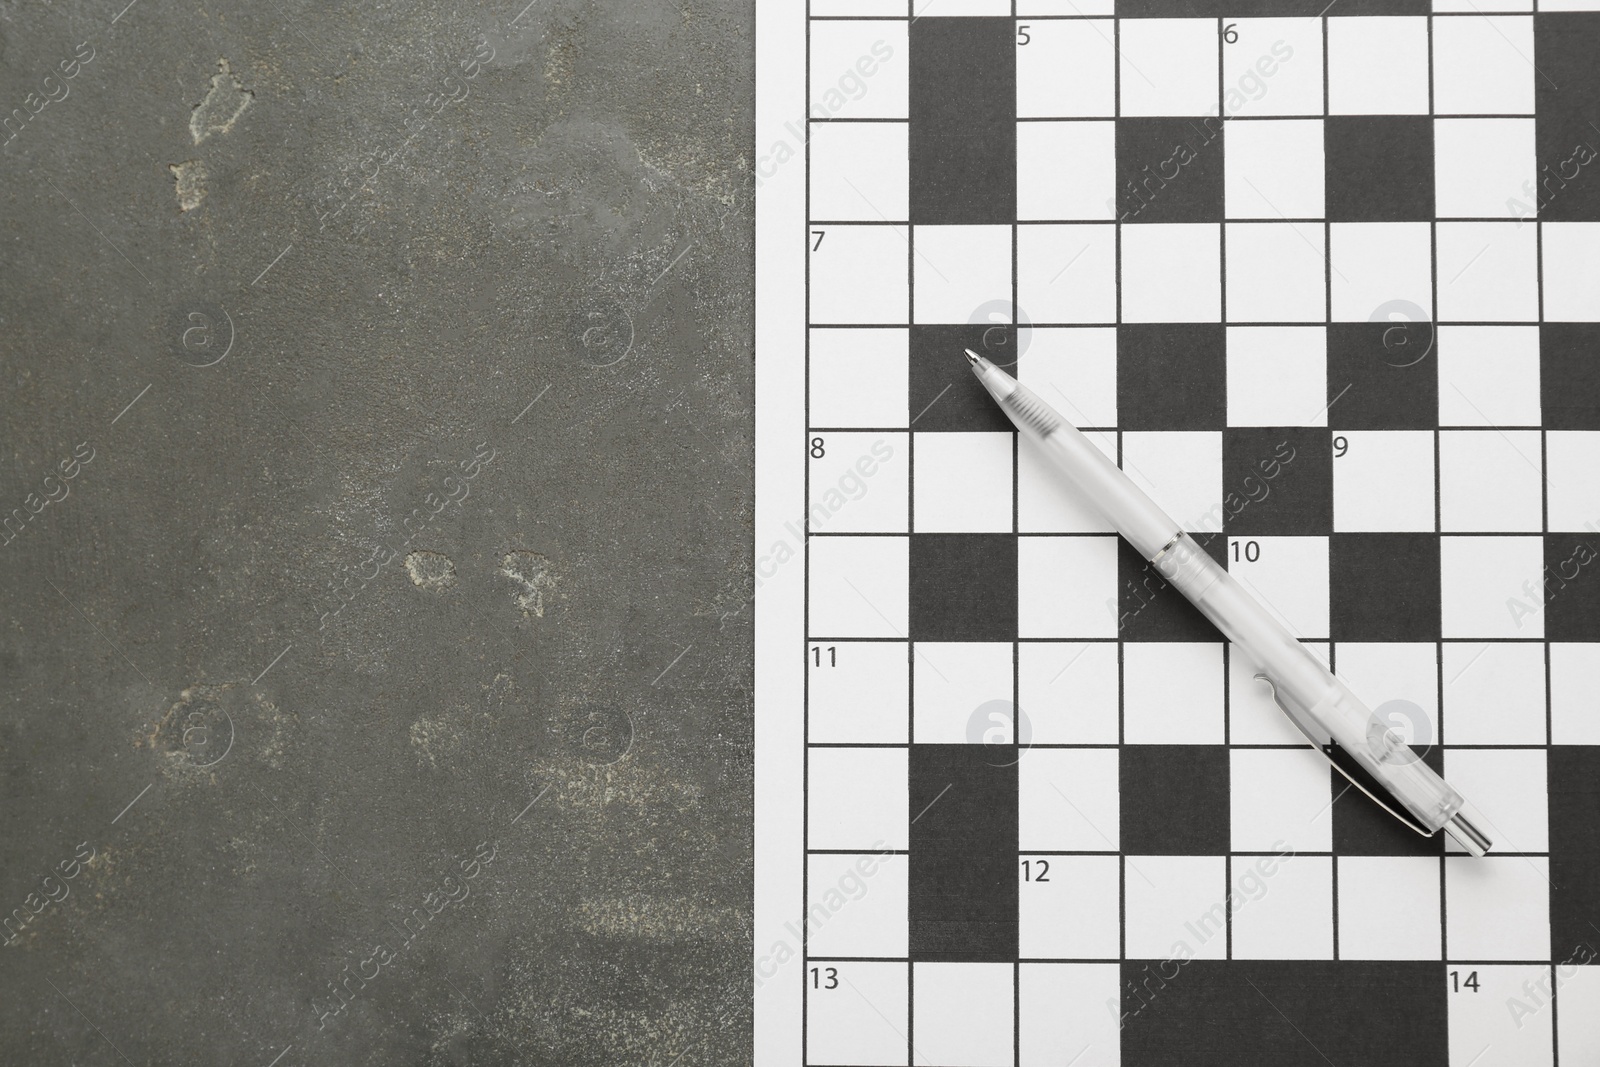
1152, 534, 1462, 832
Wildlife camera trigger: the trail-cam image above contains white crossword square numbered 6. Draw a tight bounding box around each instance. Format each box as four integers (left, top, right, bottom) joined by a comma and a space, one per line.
1222, 18, 1322, 117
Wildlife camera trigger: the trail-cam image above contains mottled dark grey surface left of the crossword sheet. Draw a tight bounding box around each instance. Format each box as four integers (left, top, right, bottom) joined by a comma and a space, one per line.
0, 0, 754, 1067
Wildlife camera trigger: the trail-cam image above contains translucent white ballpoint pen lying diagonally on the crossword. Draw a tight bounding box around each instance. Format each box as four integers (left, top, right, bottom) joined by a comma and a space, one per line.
966, 349, 1491, 856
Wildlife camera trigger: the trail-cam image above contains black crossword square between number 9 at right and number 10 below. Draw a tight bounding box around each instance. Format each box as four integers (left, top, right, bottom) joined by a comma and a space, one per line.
1222, 426, 1333, 537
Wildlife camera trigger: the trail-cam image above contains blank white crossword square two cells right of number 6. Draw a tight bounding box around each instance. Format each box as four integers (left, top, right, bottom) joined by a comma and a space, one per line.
1434, 14, 1538, 115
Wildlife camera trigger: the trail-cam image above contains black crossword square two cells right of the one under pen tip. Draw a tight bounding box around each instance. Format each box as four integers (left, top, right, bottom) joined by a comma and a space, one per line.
1117, 323, 1227, 430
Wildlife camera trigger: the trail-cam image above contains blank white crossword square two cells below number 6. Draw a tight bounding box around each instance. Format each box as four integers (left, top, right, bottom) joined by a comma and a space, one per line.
1227, 222, 1328, 322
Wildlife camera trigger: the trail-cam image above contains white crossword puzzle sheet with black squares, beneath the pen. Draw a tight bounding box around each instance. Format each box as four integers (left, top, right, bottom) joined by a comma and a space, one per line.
754, 0, 1600, 1067
